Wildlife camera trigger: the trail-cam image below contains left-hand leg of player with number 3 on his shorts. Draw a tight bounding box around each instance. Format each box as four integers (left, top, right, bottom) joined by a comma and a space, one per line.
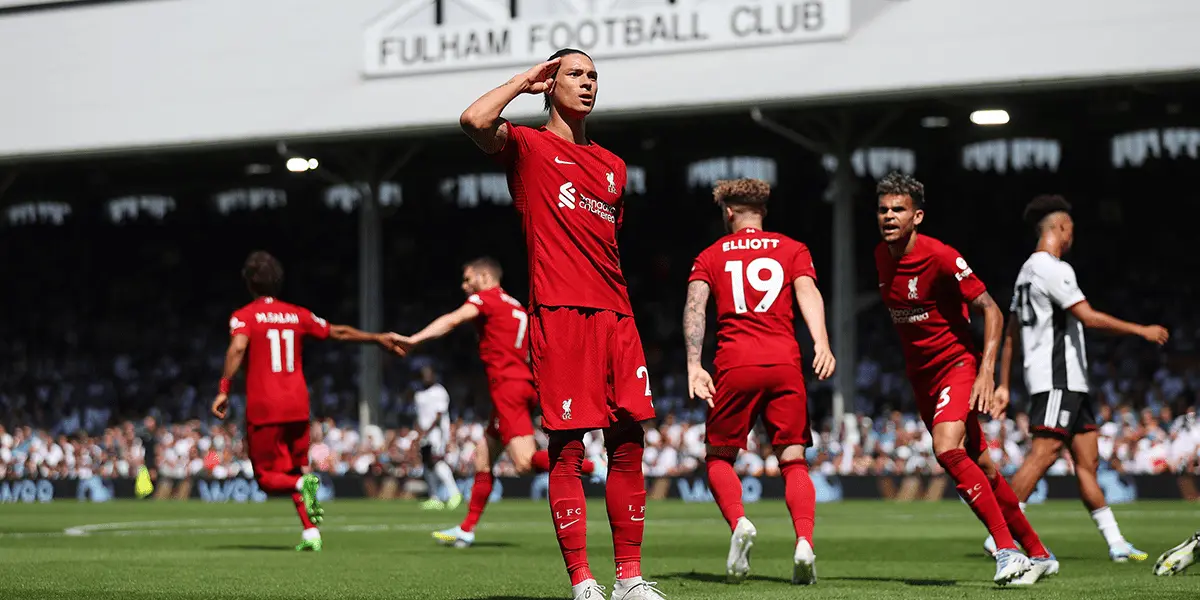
917, 376, 1032, 584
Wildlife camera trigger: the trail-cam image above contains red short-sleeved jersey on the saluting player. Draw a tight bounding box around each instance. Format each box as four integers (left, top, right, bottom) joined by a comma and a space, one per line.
499, 124, 634, 316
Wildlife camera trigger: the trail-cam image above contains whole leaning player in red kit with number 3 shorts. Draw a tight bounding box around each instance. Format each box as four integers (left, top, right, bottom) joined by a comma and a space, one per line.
875, 173, 1058, 586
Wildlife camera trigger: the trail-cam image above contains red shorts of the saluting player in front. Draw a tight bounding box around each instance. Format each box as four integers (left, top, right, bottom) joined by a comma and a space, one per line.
529, 307, 654, 431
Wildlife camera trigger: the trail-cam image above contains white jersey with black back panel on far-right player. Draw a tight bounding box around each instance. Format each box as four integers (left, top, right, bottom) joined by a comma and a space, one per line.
1009, 252, 1088, 394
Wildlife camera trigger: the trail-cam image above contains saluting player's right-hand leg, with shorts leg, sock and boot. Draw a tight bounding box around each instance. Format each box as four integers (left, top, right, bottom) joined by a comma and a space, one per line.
609, 311, 662, 600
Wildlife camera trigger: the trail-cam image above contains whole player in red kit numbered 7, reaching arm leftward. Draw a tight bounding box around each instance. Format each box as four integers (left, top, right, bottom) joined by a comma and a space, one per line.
397, 257, 595, 547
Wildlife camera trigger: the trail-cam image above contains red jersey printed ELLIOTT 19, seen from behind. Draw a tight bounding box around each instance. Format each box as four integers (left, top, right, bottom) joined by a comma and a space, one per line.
688, 228, 817, 371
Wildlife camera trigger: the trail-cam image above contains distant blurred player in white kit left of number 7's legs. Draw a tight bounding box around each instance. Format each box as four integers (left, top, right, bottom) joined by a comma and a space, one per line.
413, 365, 462, 510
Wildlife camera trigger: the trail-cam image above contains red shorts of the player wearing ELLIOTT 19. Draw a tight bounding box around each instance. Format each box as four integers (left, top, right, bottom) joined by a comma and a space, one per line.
704, 365, 812, 450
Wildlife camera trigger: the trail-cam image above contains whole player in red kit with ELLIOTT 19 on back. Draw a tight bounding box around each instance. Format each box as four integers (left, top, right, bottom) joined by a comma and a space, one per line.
683, 179, 835, 584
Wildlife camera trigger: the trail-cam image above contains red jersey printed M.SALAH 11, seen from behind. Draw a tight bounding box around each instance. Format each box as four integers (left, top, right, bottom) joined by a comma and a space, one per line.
229, 298, 329, 425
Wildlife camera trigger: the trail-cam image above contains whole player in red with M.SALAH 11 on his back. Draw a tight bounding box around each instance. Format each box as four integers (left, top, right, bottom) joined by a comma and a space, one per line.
212, 252, 395, 551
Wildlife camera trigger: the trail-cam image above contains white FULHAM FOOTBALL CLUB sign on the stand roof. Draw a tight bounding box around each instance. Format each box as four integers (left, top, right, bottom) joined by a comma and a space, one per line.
362, 0, 851, 77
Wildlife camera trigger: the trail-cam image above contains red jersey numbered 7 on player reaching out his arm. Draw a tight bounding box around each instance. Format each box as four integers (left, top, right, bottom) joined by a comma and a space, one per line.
467, 288, 533, 382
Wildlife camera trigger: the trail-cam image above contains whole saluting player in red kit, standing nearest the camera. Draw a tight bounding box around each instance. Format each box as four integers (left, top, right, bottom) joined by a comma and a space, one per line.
460, 49, 662, 600
